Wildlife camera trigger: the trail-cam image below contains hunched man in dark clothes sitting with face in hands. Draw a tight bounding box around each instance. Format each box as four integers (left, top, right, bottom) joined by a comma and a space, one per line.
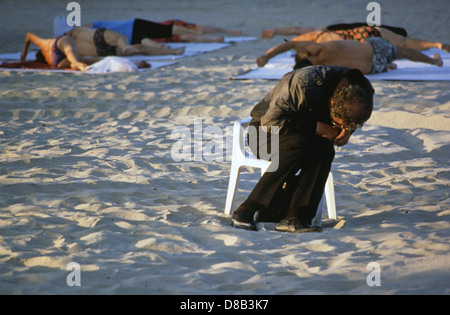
231, 66, 374, 233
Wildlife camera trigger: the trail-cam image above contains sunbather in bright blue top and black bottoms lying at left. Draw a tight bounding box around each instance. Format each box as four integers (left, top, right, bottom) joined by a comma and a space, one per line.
82, 19, 242, 45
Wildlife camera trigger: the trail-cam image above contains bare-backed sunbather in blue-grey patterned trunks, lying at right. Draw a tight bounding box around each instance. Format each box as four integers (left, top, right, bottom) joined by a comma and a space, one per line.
256, 37, 443, 74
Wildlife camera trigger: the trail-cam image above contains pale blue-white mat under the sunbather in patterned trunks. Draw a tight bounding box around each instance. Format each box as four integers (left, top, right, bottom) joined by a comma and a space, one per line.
232, 48, 450, 81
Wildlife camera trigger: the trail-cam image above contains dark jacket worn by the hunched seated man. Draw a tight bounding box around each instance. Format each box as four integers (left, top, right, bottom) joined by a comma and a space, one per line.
251, 66, 373, 135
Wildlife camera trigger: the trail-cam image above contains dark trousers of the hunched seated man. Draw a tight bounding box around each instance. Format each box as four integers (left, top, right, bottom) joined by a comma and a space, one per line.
248, 133, 335, 224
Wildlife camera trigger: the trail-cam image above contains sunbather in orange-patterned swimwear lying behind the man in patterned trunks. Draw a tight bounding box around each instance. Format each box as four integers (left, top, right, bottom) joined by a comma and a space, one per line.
261, 23, 450, 52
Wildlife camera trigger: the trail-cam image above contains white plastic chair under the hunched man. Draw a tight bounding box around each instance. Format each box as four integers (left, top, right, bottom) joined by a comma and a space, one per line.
225, 117, 337, 226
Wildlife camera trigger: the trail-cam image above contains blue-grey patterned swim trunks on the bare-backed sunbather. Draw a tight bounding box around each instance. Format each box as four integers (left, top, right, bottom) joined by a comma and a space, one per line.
366, 37, 397, 74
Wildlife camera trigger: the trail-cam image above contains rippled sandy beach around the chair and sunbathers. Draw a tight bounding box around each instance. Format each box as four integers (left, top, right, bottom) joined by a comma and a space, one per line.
0, 0, 450, 295
